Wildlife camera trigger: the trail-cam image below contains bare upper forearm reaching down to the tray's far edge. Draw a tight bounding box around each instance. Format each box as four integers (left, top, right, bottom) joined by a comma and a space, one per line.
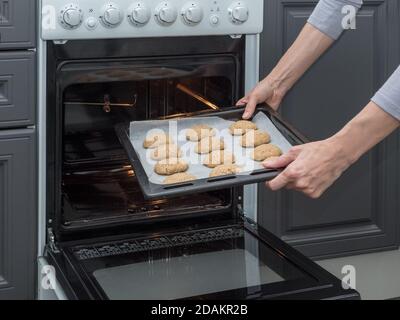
263, 24, 334, 97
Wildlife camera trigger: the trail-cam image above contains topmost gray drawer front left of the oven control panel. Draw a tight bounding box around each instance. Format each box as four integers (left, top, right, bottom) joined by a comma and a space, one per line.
0, 0, 36, 49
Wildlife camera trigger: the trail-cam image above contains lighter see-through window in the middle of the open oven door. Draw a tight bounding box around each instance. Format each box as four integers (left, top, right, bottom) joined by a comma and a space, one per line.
93, 249, 284, 300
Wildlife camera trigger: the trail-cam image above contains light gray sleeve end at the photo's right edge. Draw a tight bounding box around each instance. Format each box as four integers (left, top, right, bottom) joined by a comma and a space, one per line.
371, 66, 400, 121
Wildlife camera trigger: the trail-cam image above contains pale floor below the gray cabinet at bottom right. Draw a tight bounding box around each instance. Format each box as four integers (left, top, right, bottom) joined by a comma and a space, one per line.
317, 250, 400, 300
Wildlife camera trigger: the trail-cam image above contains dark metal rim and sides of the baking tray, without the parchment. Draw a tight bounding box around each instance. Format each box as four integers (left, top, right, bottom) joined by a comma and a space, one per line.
116, 104, 307, 199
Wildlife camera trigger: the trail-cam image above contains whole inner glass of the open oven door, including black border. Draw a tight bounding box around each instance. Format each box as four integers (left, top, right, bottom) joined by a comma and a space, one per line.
65, 227, 317, 300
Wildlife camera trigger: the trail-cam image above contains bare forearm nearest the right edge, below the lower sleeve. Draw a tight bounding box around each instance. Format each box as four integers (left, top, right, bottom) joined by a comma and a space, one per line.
328, 101, 400, 166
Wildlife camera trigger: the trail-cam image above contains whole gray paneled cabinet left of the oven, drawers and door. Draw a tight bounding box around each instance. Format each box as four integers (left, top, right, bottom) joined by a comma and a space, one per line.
0, 0, 37, 300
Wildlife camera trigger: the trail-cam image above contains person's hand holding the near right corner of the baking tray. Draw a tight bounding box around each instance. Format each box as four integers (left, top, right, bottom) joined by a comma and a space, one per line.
263, 139, 352, 199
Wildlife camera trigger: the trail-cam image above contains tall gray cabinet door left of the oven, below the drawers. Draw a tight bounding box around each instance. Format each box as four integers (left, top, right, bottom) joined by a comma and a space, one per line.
0, 130, 37, 300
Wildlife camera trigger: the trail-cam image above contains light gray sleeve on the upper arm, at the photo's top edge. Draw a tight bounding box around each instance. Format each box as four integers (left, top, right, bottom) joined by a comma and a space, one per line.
308, 0, 363, 40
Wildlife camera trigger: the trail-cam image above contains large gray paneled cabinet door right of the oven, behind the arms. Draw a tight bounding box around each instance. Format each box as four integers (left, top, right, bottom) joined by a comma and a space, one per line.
258, 0, 400, 257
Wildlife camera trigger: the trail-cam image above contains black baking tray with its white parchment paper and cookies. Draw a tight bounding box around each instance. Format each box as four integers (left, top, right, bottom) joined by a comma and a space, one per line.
116, 105, 306, 199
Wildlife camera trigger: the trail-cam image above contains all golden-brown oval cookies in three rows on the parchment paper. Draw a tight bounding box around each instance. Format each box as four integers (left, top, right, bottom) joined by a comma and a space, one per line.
143, 120, 282, 184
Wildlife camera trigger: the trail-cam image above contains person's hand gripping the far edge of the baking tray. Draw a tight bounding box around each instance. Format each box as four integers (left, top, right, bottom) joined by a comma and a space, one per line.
236, 78, 283, 119
